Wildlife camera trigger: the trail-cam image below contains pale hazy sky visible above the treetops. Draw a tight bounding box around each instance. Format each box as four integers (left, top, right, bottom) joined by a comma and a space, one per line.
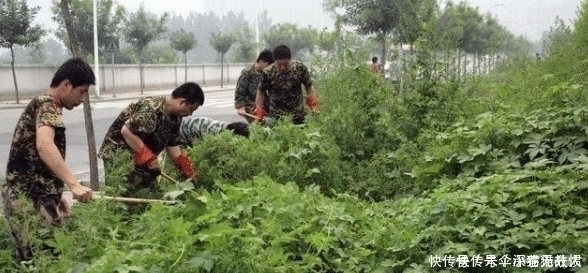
23, 0, 582, 40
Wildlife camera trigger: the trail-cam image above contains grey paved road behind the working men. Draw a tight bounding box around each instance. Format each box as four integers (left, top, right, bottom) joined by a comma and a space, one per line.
0, 86, 245, 181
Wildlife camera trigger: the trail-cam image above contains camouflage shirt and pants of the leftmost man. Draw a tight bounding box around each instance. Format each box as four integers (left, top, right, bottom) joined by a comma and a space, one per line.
2, 95, 65, 260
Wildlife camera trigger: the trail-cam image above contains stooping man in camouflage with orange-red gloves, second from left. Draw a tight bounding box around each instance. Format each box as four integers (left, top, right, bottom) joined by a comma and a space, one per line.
98, 82, 204, 198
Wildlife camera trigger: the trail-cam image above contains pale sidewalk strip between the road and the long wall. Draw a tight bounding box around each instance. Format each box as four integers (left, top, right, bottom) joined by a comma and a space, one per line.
0, 84, 235, 111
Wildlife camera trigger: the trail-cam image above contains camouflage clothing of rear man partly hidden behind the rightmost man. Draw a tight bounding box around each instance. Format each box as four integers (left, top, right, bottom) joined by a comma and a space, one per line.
235, 65, 269, 123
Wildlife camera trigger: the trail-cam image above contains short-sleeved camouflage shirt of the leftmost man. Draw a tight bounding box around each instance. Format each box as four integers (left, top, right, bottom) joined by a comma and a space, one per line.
6, 95, 65, 197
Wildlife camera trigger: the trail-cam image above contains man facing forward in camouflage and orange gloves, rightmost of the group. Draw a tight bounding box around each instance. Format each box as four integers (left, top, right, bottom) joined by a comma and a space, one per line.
254, 45, 319, 124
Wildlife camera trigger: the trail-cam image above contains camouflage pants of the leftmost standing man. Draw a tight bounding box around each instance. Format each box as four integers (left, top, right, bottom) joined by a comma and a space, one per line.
2, 184, 64, 261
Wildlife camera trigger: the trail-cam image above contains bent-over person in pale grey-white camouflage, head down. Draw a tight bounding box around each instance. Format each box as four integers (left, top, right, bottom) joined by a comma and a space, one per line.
180, 117, 249, 146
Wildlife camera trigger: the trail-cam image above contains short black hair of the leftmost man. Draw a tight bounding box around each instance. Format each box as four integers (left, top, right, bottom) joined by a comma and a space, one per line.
51, 58, 96, 87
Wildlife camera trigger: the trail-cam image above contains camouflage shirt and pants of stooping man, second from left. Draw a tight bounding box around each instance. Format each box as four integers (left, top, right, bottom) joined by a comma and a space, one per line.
98, 96, 182, 198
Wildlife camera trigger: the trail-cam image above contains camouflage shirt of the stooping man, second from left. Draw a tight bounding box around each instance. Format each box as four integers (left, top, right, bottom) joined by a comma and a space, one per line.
98, 96, 182, 159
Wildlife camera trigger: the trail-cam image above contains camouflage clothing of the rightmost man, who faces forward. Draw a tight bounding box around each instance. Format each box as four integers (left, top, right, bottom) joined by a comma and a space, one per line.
259, 60, 312, 124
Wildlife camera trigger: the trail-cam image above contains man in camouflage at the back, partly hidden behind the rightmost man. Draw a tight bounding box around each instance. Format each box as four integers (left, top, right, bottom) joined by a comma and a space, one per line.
235, 49, 274, 123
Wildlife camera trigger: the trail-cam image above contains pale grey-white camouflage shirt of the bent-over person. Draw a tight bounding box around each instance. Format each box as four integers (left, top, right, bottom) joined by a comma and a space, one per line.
180, 117, 228, 145
